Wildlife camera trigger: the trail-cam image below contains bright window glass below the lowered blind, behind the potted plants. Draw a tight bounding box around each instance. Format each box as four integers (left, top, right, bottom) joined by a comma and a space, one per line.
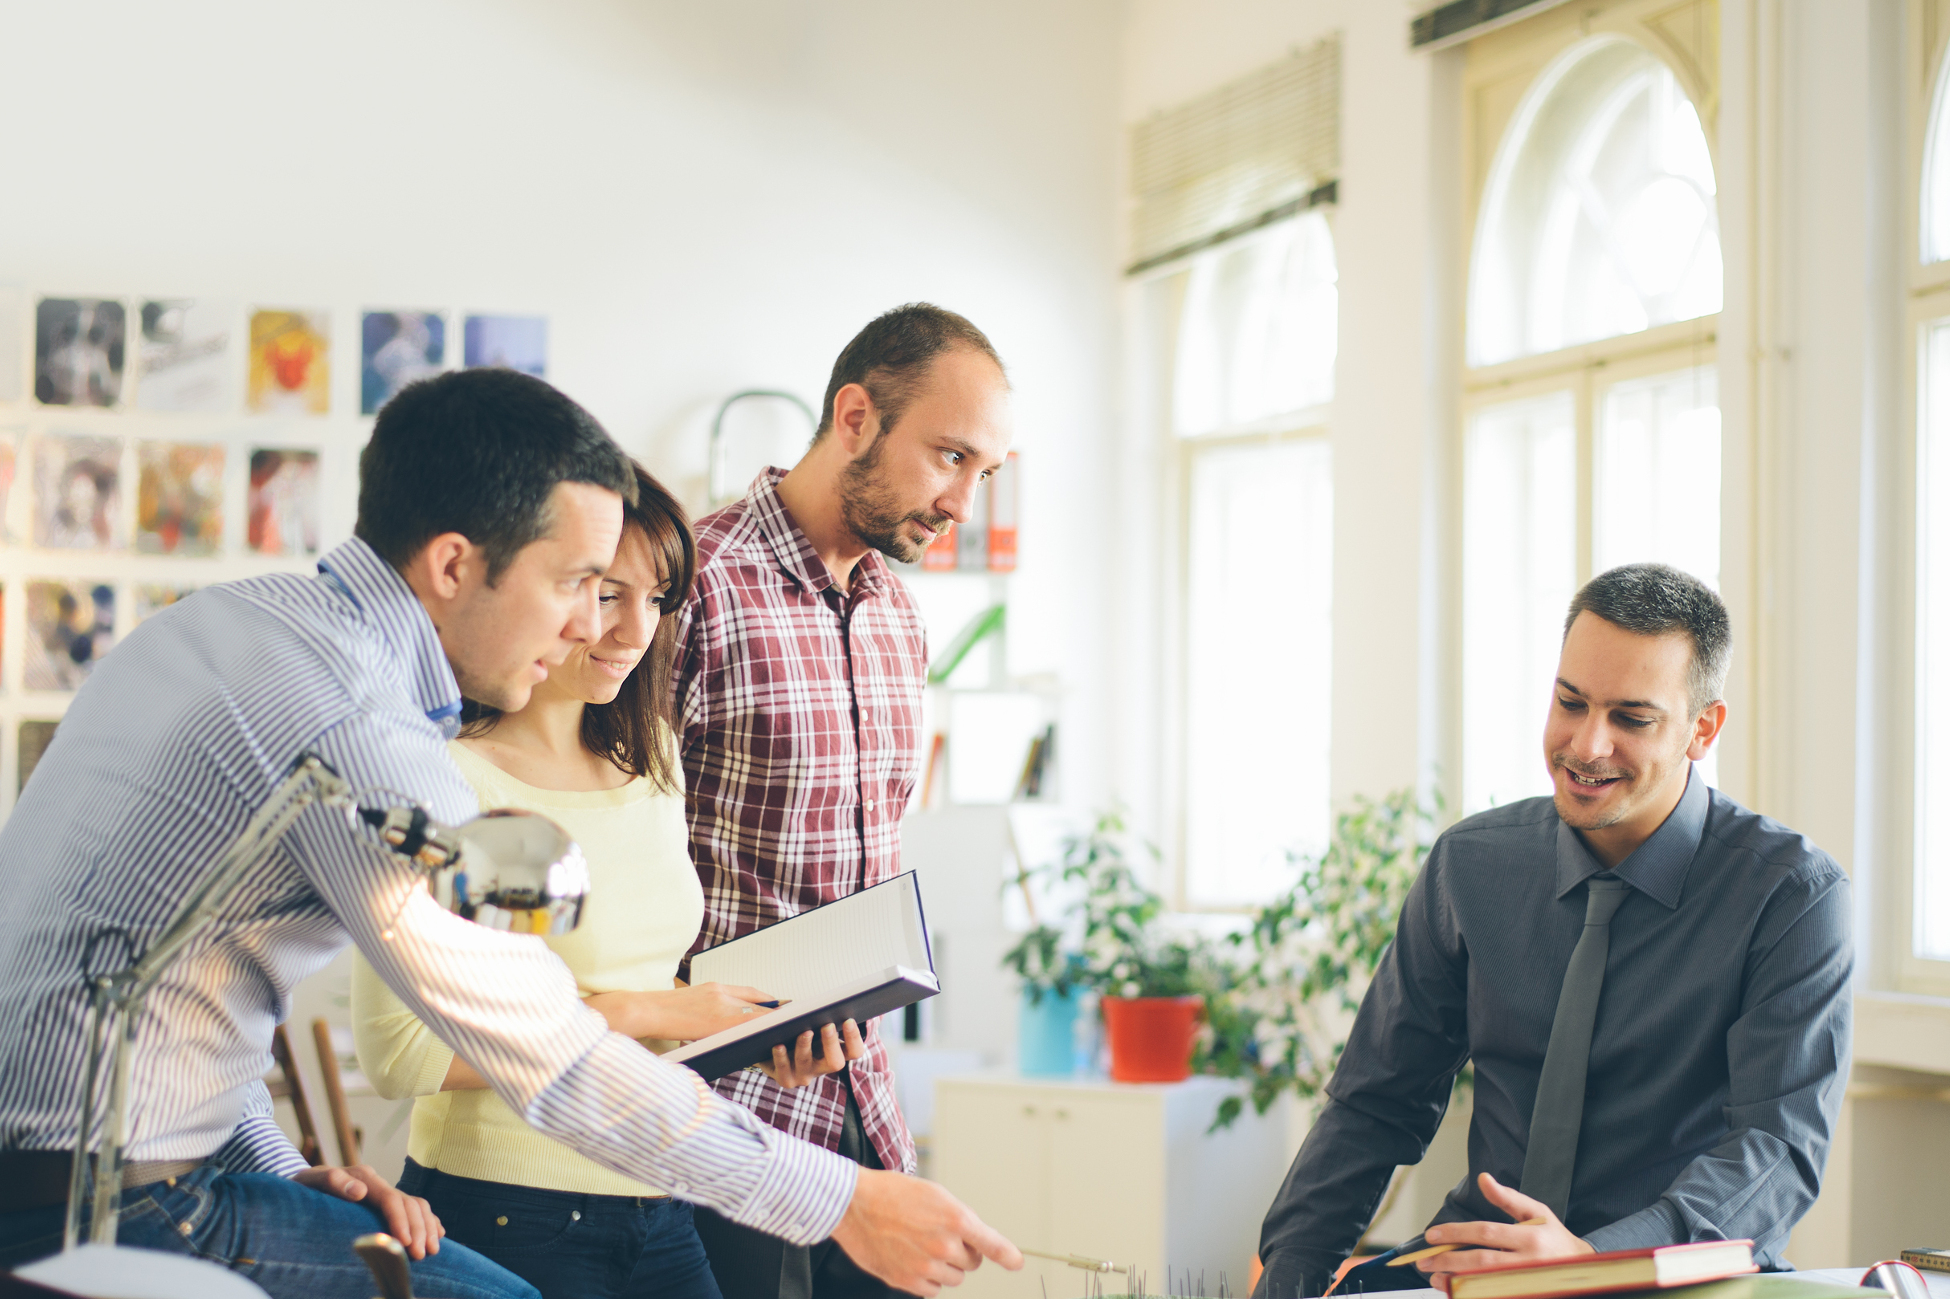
1147, 211, 1340, 907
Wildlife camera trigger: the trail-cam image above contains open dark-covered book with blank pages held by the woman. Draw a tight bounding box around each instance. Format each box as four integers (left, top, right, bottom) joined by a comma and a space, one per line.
663, 872, 942, 1081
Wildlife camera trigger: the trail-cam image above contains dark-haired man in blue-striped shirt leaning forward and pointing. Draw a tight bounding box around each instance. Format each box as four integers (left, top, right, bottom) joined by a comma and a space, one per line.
0, 371, 1018, 1299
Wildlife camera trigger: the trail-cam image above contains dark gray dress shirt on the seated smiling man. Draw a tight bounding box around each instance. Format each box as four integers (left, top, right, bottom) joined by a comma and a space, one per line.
1256, 776, 1854, 1299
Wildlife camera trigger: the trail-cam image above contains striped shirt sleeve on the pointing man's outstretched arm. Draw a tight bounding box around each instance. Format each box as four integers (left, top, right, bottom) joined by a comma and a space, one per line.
291, 714, 856, 1244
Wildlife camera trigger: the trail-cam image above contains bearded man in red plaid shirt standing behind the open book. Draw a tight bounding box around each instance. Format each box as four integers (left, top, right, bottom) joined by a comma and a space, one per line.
675, 302, 1010, 1299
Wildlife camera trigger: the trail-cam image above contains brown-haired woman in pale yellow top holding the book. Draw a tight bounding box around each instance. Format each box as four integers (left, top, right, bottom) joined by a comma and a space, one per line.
353, 466, 864, 1299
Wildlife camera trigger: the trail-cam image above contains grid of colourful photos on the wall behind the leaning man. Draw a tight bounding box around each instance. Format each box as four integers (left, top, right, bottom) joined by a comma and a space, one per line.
0, 283, 548, 811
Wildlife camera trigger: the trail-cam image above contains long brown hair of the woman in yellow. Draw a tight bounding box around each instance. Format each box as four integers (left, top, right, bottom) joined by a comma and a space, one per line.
460, 460, 698, 794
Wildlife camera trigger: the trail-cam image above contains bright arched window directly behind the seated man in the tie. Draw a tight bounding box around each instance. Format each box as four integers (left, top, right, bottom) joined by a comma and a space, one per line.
1459, 31, 1722, 811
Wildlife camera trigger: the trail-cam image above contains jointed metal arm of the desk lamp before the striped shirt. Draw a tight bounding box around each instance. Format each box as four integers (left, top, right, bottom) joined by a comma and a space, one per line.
62, 753, 353, 1248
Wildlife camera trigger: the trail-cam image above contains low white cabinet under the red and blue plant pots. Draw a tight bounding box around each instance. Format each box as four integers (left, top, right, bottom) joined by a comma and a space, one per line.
932, 1077, 1287, 1299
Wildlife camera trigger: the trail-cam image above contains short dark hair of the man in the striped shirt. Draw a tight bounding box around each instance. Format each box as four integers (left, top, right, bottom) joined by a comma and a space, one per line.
353, 369, 636, 585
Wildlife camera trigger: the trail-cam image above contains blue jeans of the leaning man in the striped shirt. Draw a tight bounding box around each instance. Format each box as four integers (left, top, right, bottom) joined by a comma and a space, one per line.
0, 1164, 538, 1299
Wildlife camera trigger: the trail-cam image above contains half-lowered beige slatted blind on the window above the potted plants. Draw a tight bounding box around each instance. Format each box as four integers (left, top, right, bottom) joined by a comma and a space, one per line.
1129, 37, 1340, 275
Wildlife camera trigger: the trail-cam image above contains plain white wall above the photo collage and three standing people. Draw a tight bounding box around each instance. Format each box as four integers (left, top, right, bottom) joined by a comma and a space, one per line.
0, 0, 1115, 811
